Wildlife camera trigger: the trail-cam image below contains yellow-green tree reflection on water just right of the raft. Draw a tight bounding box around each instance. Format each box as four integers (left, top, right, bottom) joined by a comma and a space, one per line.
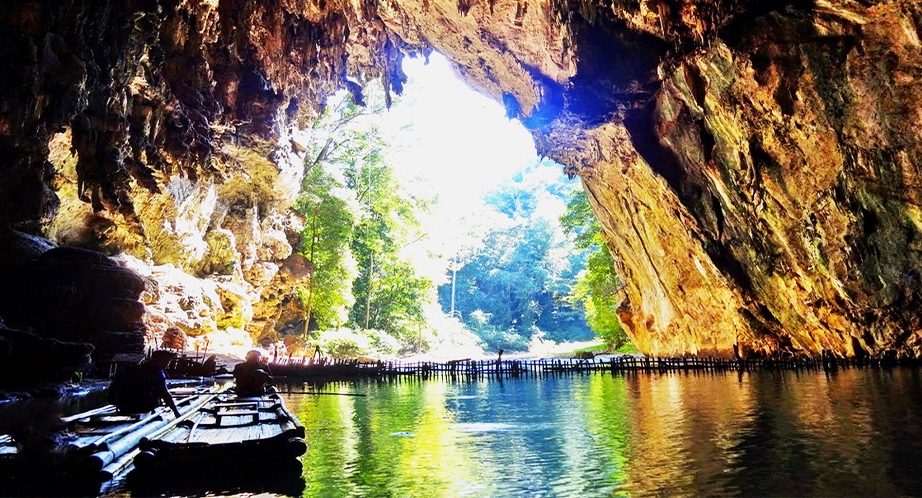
288, 383, 475, 496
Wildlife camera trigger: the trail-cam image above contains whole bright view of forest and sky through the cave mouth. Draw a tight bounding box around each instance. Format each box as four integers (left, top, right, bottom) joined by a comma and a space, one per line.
290, 53, 627, 358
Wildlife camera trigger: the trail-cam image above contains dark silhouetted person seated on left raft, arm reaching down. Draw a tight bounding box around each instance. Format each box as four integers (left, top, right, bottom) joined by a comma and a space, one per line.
108, 349, 179, 417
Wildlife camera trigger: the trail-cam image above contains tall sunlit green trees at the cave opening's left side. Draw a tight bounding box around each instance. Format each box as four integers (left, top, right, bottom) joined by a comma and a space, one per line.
298, 82, 433, 351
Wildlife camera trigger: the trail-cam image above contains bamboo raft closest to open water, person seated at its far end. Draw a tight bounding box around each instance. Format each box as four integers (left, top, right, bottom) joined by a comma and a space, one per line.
132, 386, 307, 475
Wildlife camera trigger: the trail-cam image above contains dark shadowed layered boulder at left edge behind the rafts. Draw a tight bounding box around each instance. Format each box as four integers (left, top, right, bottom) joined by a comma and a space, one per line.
0, 239, 145, 385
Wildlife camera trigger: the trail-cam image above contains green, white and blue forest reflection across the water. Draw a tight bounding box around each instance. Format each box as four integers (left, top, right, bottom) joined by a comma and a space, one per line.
287, 375, 628, 497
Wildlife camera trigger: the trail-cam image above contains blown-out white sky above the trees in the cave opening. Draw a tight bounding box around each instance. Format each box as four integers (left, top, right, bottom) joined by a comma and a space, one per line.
376, 53, 537, 209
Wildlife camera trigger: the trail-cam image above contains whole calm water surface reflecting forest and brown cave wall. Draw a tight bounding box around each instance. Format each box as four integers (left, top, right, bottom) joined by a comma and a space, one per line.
120, 369, 922, 497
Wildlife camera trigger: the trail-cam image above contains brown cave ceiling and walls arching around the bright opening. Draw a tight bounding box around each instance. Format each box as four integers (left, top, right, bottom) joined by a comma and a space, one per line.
0, 0, 922, 366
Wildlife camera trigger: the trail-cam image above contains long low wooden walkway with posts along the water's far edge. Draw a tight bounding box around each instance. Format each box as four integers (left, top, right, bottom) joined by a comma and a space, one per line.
269, 355, 922, 379
